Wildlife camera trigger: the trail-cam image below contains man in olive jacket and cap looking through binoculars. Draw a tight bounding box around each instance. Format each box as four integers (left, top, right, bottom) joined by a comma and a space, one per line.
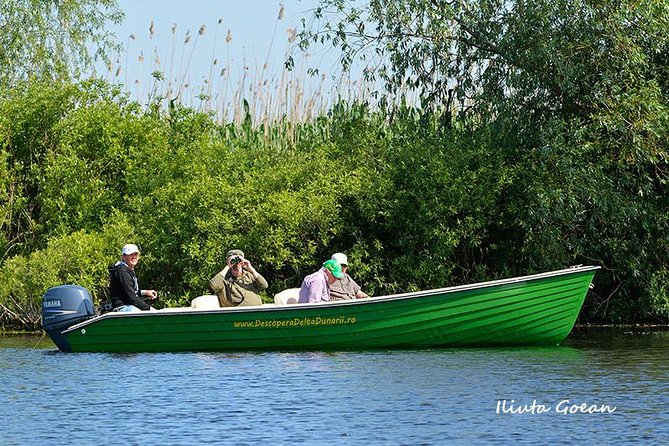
209, 249, 267, 307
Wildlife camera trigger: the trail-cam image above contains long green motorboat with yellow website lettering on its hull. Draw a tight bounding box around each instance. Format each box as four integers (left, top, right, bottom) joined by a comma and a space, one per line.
42, 266, 599, 352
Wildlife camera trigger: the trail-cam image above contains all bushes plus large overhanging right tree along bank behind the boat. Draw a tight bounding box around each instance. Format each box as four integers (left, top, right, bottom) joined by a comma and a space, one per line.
0, 0, 669, 328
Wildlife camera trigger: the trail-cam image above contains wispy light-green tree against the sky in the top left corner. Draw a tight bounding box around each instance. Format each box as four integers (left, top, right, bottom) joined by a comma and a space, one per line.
0, 0, 123, 89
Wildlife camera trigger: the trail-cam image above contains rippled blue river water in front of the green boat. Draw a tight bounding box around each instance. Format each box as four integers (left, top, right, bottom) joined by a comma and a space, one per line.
0, 329, 669, 445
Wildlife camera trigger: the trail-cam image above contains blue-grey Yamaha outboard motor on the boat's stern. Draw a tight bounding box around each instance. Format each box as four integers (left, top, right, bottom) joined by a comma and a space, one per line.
42, 285, 95, 352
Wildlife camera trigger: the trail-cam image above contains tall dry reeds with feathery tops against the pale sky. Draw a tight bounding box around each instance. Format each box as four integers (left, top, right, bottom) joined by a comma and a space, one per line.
96, 5, 384, 128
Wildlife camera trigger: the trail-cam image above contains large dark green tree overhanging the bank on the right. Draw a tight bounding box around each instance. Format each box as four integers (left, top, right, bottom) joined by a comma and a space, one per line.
301, 0, 669, 320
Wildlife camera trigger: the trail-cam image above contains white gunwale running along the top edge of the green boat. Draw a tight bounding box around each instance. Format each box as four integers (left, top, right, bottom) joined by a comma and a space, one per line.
62, 265, 601, 334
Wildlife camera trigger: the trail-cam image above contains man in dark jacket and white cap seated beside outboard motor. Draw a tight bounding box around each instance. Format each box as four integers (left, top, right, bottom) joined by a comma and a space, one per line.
109, 243, 158, 311
